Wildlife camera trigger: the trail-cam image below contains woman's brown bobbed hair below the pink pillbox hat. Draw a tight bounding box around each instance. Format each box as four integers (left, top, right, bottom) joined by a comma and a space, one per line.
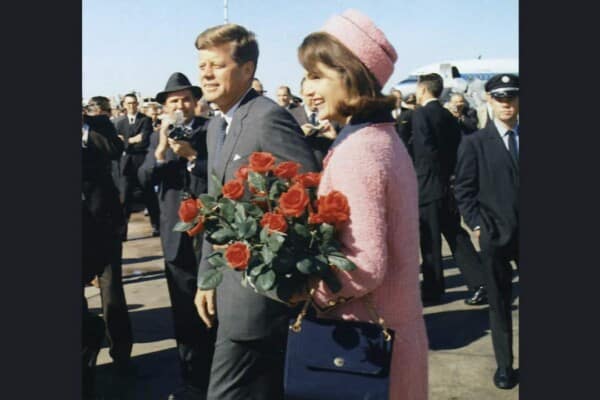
298, 32, 396, 120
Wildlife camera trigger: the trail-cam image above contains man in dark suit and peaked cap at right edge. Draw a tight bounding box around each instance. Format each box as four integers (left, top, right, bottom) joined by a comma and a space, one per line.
454, 74, 520, 389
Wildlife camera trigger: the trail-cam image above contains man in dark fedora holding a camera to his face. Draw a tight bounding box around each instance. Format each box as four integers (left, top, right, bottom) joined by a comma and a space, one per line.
139, 72, 215, 400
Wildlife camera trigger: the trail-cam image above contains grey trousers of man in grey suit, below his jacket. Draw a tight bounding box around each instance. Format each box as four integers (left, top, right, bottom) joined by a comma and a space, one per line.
207, 336, 286, 400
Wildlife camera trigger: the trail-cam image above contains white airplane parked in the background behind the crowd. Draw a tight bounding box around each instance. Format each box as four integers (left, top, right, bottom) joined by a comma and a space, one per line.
393, 58, 519, 96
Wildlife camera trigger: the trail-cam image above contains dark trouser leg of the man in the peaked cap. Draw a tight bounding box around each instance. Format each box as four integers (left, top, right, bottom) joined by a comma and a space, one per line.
481, 239, 513, 367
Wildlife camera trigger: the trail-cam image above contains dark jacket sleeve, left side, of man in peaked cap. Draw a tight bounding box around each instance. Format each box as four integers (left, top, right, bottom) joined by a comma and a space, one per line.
454, 136, 481, 229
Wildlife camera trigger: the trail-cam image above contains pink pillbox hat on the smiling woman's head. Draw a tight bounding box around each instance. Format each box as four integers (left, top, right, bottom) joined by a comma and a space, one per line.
321, 9, 398, 88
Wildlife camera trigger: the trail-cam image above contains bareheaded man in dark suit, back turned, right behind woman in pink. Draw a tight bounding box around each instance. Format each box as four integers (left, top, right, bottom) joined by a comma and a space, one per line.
412, 73, 485, 305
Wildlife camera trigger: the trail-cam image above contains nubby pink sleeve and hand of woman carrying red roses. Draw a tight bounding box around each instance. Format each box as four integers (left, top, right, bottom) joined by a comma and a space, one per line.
313, 142, 388, 307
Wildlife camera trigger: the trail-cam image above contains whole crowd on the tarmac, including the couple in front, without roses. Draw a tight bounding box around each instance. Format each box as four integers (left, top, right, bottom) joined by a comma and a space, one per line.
82, 10, 519, 400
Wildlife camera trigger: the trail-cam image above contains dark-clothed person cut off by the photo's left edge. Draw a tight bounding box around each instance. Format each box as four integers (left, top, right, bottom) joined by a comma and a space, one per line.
81, 111, 126, 399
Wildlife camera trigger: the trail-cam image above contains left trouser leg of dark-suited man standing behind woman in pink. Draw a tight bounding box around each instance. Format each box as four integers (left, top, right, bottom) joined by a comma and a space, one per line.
419, 200, 445, 296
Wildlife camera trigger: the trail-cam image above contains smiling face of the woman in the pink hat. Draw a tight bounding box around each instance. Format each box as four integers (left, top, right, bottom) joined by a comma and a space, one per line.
304, 62, 347, 124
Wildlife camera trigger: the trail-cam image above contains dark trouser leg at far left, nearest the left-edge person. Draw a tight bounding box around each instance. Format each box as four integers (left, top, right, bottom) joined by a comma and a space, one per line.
99, 238, 133, 362
